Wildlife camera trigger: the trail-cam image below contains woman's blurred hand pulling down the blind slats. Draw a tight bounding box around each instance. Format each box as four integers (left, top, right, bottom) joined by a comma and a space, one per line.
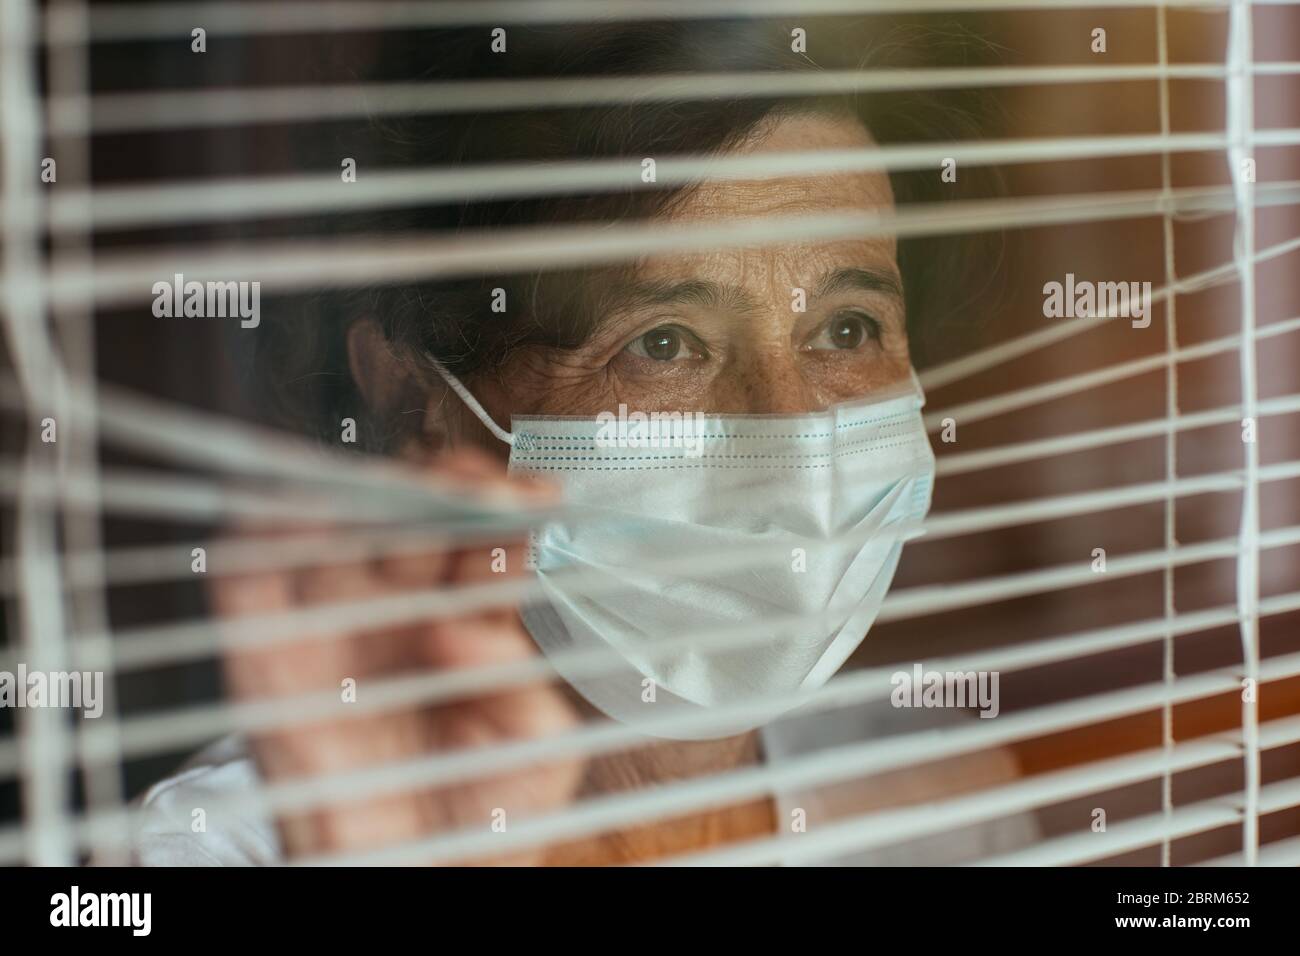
212, 451, 582, 864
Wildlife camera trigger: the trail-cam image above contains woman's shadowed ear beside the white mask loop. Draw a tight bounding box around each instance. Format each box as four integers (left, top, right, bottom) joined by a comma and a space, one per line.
347, 319, 449, 460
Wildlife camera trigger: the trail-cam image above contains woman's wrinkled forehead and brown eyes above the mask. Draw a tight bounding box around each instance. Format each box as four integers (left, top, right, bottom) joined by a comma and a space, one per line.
456, 114, 910, 451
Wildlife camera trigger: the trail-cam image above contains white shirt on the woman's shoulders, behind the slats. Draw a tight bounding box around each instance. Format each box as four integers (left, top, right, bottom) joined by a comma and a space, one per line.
122, 700, 1039, 866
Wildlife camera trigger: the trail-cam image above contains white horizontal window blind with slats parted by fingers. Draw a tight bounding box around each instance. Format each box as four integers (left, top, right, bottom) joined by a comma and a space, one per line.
0, 0, 1300, 865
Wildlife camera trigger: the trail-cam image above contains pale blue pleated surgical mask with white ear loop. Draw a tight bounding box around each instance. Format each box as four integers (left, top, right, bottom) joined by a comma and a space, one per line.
428, 371, 935, 739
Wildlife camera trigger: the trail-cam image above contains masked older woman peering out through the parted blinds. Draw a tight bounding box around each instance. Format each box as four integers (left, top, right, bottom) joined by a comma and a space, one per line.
124, 23, 1031, 865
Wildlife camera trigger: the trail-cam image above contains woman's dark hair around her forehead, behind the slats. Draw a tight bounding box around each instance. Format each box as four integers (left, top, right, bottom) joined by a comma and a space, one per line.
243, 18, 1000, 450
